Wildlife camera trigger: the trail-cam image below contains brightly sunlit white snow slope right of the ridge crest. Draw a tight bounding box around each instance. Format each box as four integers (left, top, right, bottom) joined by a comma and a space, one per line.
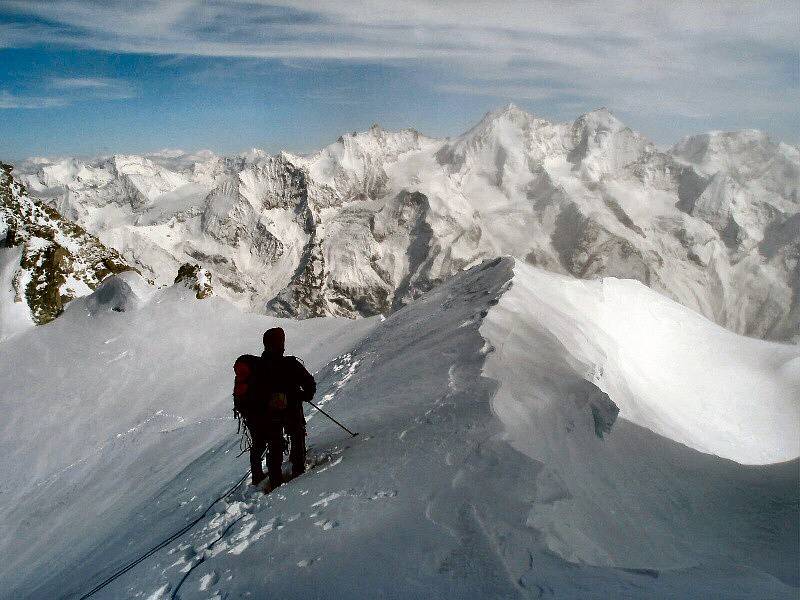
482, 263, 800, 464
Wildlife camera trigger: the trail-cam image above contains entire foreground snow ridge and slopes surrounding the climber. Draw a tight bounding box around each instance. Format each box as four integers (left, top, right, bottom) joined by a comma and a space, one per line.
0, 258, 800, 600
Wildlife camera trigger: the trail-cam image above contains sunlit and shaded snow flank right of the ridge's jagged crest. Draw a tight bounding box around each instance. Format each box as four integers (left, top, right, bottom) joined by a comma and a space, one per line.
481, 264, 800, 576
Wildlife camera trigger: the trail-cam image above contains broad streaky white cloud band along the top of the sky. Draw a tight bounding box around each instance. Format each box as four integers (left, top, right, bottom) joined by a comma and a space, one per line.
0, 0, 800, 124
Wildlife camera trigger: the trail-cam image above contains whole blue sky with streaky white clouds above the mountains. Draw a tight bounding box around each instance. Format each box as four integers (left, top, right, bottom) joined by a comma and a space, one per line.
0, 0, 800, 160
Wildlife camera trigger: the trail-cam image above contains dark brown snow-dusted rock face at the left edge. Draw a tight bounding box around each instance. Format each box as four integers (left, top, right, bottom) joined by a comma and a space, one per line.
0, 163, 131, 325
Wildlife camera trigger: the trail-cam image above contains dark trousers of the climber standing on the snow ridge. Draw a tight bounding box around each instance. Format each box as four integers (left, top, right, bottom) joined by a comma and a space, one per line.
250, 421, 306, 485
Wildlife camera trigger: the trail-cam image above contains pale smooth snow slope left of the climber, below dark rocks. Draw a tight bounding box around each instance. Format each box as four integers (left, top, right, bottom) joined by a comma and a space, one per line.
0, 272, 378, 597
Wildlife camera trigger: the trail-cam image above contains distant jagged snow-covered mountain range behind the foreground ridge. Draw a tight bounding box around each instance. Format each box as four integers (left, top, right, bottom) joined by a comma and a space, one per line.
14, 105, 800, 340
